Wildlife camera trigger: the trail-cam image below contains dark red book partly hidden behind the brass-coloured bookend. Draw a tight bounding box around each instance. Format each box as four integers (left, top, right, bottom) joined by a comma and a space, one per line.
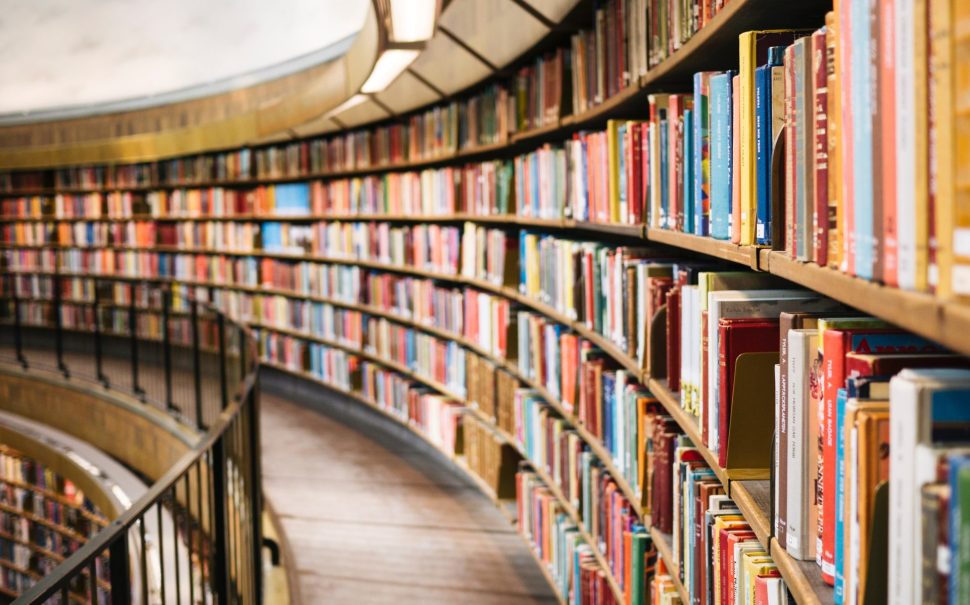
718, 318, 778, 468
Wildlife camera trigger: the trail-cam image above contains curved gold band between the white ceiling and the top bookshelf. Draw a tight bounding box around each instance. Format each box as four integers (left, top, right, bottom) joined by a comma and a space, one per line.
0, 3, 386, 169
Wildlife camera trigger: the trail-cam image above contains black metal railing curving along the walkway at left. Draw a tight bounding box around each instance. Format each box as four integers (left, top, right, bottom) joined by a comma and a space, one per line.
0, 273, 262, 605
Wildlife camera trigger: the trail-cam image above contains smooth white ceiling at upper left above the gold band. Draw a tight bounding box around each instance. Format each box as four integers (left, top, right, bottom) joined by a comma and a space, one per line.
0, 0, 370, 117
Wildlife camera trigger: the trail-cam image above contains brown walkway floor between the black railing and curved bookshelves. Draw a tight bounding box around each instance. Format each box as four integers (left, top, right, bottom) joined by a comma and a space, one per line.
261, 375, 556, 605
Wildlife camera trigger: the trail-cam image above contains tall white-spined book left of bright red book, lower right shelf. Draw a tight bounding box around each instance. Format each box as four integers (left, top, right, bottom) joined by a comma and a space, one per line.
785, 329, 818, 561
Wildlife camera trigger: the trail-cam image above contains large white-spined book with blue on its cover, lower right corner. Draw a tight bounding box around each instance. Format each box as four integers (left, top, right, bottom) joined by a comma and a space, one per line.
888, 370, 970, 605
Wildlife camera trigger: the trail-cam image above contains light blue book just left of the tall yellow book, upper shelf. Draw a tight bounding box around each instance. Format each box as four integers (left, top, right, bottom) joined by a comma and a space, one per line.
710, 71, 735, 240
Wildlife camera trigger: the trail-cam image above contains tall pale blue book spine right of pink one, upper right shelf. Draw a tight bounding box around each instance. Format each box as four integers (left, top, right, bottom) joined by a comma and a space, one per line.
843, 2, 876, 279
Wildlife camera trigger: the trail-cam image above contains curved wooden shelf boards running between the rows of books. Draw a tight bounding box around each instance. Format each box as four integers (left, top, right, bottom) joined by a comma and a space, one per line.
0, 0, 956, 603
